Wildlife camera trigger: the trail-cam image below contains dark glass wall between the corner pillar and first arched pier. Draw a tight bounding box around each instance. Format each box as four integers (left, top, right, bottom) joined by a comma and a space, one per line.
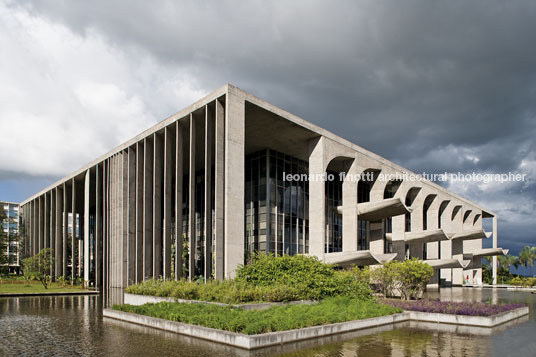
244, 149, 309, 260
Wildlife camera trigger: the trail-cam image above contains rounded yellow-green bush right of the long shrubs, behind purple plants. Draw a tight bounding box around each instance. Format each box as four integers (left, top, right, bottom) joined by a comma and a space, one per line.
396, 258, 434, 300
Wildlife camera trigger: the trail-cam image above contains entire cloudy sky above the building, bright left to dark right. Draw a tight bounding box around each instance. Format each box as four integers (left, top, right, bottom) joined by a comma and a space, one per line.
0, 0, 536, 266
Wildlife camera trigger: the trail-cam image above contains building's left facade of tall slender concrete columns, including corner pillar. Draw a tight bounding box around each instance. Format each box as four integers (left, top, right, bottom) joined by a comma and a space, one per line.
19, 90, 245, 292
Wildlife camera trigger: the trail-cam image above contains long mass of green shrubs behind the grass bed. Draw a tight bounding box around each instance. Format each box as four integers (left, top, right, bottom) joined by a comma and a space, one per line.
126, 255, 372, 304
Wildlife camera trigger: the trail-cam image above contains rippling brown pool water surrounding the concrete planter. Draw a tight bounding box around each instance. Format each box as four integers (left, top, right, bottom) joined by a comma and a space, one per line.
0, 288, 536, 357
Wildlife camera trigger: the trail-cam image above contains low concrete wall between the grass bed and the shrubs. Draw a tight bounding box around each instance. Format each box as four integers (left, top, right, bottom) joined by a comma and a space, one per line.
123, 293, 316, 310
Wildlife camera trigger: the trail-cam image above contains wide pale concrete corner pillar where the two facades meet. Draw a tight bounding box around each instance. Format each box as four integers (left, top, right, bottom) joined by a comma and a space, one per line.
224, 87, 246, 279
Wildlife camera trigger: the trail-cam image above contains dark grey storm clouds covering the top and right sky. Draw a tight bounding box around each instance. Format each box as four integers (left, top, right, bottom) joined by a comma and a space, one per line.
4, 1, 536, 256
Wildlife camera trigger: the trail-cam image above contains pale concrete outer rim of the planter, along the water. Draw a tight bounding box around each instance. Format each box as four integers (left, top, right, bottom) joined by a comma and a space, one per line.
103, 307, 529, 350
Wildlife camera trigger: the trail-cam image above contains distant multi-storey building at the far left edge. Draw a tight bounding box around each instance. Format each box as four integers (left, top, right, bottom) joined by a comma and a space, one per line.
0, 201, 22, 273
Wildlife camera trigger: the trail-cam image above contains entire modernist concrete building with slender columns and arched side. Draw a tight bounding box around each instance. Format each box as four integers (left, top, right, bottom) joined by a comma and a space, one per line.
21, 85, 504, 290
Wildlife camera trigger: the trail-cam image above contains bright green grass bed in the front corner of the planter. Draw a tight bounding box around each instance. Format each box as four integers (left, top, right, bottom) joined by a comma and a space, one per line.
112, 297, 402, 335
